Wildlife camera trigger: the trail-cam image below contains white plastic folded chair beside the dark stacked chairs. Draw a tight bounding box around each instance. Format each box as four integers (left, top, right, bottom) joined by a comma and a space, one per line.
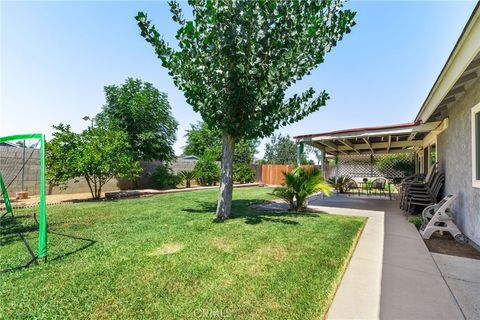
420, 194, 468, 244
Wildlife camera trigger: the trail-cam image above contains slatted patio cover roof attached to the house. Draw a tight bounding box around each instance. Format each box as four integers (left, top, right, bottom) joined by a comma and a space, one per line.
294, 121, 441, 155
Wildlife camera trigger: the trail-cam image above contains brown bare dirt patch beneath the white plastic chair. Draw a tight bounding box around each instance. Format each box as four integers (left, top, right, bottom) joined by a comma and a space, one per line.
424, 233, 480, 260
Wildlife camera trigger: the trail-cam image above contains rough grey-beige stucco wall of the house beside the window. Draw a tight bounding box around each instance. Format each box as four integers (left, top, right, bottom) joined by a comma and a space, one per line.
437, 79, 480, 245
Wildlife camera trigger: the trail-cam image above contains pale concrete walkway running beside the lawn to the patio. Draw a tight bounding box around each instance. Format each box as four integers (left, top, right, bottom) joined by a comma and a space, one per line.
309, 196, 464, 320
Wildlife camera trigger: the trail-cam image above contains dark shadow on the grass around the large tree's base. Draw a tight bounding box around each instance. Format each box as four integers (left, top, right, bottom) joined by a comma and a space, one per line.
182, 199, 319, 225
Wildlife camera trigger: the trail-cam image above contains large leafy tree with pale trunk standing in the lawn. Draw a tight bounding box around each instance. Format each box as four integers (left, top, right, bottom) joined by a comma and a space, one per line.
136, 0, 355, 220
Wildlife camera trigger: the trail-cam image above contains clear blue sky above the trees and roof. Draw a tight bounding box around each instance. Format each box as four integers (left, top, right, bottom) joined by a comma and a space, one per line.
0, 0, 475, 158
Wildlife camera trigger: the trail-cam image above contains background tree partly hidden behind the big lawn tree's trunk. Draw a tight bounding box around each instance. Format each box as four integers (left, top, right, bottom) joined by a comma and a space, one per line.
183, 121, 259, 164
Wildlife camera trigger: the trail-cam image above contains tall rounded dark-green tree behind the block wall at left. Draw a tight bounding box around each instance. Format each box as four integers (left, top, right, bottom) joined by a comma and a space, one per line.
95, 78, 178, 161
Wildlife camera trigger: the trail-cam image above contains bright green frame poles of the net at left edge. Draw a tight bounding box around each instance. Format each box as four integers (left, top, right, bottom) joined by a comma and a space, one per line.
0, 133, 47, 258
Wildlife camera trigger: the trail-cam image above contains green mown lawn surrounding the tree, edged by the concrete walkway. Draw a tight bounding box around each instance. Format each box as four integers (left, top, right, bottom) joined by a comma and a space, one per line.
0, 188, 365, 319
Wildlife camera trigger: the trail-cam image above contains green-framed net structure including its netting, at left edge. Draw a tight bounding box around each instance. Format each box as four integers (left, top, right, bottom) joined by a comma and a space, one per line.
0, 133, 47, 271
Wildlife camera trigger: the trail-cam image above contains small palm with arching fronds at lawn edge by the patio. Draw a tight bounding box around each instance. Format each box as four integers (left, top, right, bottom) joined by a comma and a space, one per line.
273, 167, 331, 211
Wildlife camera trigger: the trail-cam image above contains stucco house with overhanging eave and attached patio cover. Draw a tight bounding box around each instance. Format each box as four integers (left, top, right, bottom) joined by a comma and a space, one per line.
295, 3, 480, 247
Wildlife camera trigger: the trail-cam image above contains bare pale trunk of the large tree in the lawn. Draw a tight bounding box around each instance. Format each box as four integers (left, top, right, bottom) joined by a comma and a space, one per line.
217, 133, 235, 221
